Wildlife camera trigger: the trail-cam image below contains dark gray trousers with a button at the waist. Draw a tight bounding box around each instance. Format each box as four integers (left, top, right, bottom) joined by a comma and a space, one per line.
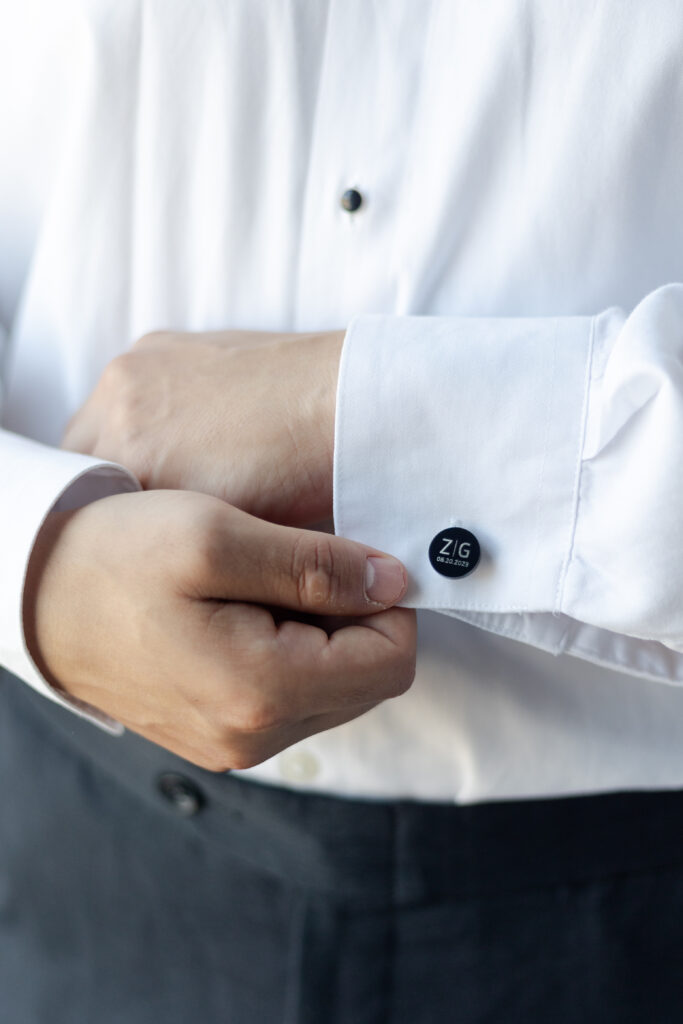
0, 672, 683, 1024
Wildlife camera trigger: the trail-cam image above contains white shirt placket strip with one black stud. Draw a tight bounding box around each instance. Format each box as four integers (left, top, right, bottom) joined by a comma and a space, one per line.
295, 0, 429, 331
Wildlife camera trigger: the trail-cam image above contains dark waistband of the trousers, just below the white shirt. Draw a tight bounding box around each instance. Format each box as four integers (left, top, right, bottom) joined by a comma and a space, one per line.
5, 672, 683, 907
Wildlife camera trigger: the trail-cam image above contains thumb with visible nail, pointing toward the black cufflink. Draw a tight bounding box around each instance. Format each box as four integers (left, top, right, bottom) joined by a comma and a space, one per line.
194, 505, 408, 615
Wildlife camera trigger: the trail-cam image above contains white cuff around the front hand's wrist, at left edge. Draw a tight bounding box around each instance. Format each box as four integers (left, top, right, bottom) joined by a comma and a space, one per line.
0, 430, 141, 734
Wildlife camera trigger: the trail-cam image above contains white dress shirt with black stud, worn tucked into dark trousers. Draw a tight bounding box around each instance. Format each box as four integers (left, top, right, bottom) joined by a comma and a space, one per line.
0, 0, 683, 802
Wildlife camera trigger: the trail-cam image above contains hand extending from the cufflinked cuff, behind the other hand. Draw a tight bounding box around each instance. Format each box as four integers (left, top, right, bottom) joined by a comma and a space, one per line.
62, 331, 344, 525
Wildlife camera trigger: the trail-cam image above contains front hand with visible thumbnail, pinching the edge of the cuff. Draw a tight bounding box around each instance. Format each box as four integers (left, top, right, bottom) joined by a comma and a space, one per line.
25, 490, 415, 771
